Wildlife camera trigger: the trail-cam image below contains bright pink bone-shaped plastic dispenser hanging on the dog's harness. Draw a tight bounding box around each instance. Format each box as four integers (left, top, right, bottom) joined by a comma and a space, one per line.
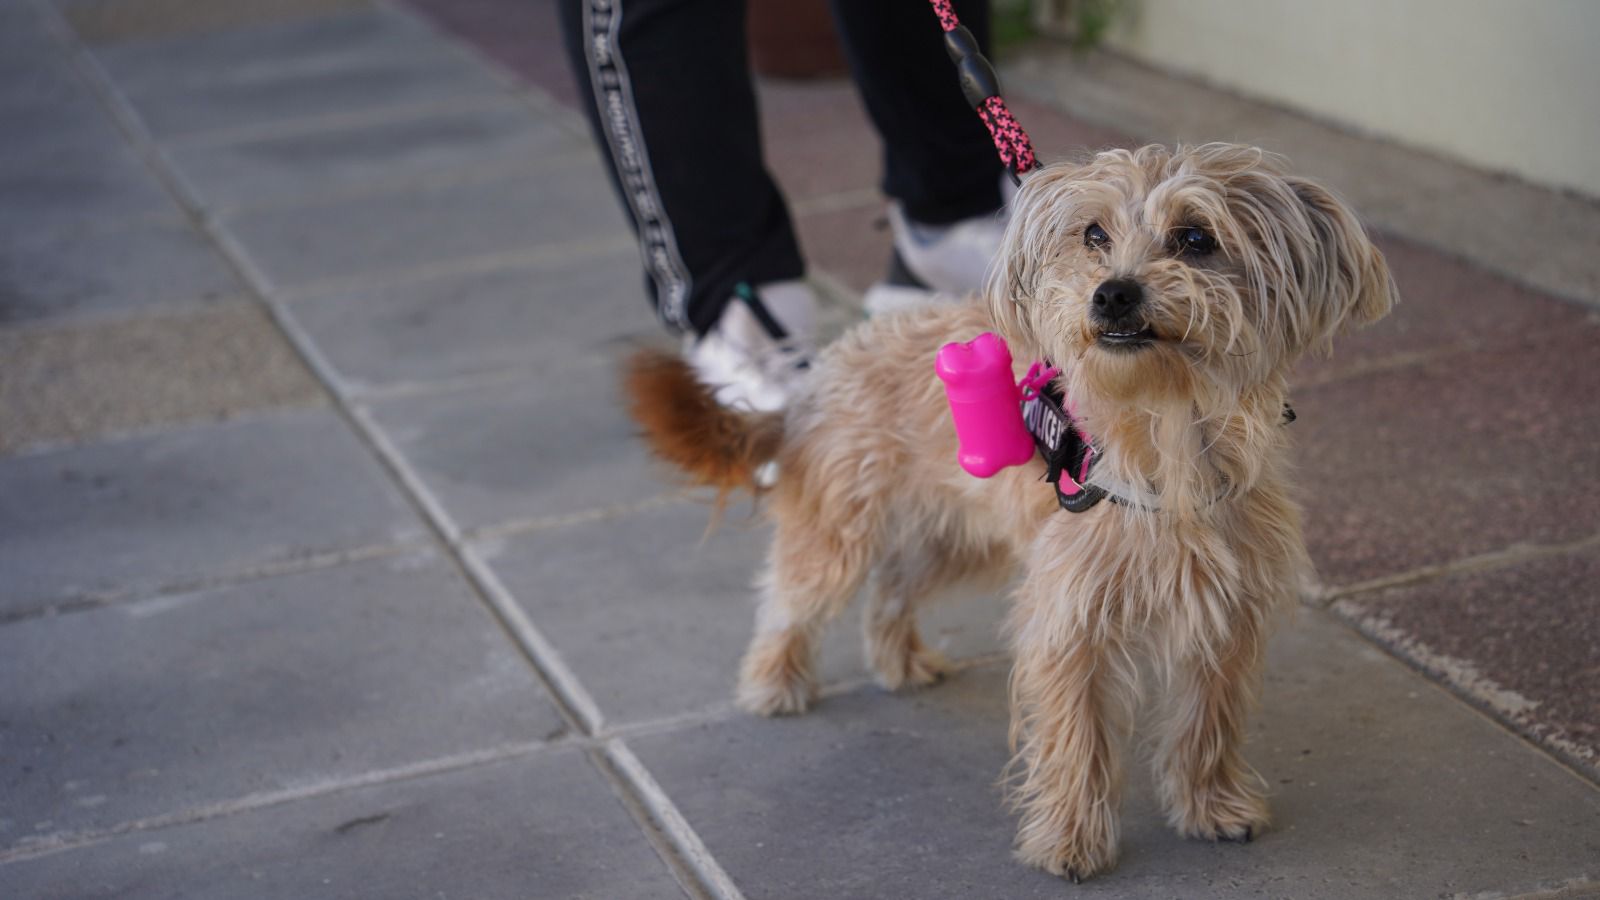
934, 331, 1034, 479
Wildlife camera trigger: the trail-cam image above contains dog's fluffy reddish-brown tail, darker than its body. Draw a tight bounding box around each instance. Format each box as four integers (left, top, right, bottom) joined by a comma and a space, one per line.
622, 349, 784, 503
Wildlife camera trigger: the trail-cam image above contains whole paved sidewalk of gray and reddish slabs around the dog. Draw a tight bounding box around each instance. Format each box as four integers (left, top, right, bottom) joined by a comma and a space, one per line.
0, 0, 1600, 898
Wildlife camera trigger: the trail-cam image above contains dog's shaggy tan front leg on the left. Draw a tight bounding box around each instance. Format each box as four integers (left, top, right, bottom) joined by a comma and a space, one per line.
1011, 578, 1136, 881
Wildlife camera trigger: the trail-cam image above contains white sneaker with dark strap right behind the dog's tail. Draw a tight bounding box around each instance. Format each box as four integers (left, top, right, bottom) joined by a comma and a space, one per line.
683, 280, 816, 413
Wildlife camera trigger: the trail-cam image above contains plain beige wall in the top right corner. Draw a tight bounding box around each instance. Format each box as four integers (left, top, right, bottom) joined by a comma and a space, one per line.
1109, 0, 1600, 197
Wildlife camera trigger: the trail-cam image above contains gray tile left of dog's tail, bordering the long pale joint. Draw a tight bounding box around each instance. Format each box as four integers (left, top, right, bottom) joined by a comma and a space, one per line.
371, 359, 669, 528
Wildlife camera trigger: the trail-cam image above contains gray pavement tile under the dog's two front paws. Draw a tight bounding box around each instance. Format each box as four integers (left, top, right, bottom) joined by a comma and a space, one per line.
630, 613, 1600, 900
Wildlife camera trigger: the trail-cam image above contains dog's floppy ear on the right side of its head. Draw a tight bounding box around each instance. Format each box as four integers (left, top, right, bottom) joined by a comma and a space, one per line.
1288, 178, 1400, 346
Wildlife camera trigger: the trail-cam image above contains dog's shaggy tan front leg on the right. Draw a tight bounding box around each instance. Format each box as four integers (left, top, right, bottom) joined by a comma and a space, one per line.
1154, 617, 1267, 841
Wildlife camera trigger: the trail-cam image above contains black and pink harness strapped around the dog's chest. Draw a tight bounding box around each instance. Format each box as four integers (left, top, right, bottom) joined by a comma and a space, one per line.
1022, 362, 1296, 512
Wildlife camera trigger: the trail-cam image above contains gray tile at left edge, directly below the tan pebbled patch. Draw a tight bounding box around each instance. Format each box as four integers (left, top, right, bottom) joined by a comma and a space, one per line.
0, 403, 424, 617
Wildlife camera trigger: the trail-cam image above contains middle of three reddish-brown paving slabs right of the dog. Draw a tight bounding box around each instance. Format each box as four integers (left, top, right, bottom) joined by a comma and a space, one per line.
1293, 325, 1600, 585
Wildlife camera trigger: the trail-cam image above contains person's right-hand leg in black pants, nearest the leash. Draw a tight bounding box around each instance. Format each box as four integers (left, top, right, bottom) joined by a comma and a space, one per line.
832, 0, 1002, 226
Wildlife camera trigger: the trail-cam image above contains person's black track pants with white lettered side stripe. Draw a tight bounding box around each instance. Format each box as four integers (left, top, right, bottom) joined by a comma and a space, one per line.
560, 0, 1002, 333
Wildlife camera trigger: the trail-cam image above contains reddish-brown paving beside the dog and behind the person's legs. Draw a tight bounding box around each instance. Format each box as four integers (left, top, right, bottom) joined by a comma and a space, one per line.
403, 0, 1600, 771
